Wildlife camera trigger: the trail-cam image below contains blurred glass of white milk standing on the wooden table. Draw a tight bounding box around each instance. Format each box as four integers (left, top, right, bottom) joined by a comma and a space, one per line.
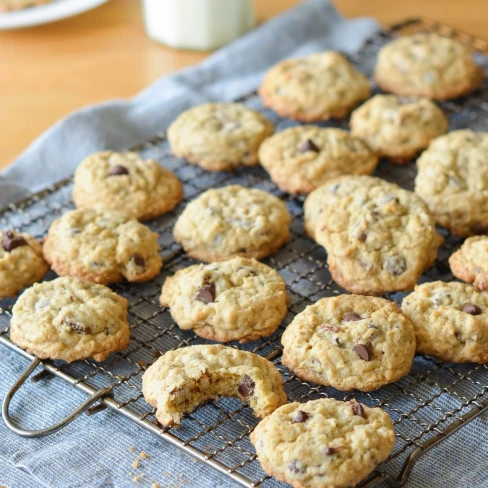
142, 0, 256, 50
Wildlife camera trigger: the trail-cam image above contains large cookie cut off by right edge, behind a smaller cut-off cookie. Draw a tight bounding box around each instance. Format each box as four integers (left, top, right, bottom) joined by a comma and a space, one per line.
415, 130, 488, 236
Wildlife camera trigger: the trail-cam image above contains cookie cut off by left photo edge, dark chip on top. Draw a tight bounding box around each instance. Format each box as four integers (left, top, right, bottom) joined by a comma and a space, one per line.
0, 230, 49, 299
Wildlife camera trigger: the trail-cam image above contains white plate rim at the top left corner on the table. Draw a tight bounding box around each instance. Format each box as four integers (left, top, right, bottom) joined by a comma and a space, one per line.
0, 0, 108, 30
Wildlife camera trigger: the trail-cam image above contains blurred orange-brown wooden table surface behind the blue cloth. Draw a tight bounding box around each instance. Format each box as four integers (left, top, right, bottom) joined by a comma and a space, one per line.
0, 0, 488, 168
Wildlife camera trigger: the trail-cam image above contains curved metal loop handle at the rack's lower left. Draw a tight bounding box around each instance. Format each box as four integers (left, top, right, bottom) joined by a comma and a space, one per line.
2, 358, 111, 437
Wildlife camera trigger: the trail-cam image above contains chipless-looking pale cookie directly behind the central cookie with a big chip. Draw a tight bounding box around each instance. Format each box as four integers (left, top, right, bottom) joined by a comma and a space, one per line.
173, 185, 291, 262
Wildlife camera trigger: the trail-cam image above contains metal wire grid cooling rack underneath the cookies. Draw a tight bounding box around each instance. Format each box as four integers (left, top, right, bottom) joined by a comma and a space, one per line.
0, 19, 488, 488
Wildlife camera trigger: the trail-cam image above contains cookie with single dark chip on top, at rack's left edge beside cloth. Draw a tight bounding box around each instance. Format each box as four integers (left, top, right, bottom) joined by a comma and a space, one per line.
73, 151, 183, 220
